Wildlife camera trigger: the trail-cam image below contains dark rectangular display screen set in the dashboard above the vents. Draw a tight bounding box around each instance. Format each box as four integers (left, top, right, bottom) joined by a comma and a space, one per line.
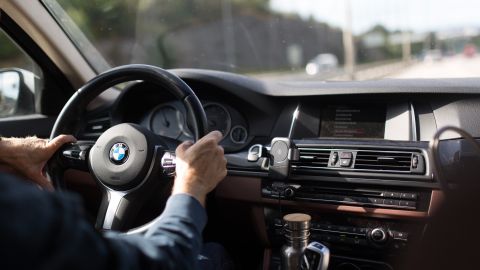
320, 105, 386, 139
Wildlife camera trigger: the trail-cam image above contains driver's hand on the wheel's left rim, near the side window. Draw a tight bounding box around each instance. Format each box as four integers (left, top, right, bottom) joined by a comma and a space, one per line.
0, 135, 76, 190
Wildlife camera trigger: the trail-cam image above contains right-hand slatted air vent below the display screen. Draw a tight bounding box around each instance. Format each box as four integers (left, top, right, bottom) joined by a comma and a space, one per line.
354, 151, 412, 172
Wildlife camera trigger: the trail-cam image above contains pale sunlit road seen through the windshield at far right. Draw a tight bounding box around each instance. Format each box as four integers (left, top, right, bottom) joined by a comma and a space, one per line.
386, 55, 480, 79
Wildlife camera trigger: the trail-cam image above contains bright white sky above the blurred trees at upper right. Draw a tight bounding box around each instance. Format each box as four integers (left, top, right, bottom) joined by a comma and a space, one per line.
270, 0, 480, 34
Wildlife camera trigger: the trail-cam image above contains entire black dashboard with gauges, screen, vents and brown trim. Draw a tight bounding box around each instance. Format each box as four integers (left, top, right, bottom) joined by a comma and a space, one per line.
80, 70, 480, 269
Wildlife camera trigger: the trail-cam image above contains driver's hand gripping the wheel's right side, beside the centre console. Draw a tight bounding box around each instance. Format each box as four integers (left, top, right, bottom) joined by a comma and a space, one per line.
172, 131, 227, 205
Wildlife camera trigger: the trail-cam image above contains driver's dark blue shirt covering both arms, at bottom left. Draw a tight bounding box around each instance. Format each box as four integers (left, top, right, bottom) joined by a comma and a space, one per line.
0, 175, 206, 270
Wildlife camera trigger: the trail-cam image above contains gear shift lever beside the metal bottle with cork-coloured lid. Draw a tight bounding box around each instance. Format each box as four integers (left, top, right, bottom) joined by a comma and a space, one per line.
300, 242, 330, 270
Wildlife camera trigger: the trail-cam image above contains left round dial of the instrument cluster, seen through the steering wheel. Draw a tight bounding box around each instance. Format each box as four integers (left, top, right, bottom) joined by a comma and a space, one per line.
150, 105, 185, 139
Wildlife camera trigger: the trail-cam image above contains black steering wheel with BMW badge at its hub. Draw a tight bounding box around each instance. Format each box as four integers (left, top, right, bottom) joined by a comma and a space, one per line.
47, 64, 207, 230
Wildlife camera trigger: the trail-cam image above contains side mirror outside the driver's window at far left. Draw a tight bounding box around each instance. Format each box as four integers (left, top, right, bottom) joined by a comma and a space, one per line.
0, 69, 35, 118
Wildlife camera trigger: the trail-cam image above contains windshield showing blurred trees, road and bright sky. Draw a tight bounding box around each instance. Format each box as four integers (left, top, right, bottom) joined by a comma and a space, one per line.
44, 0, 480, 81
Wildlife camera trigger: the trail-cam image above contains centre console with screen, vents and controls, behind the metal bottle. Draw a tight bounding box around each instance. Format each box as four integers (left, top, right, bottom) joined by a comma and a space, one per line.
253, 100, 438, 270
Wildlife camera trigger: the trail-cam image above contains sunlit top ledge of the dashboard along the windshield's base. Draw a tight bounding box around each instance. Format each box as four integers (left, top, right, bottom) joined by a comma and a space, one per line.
171, 69, 480, 97
